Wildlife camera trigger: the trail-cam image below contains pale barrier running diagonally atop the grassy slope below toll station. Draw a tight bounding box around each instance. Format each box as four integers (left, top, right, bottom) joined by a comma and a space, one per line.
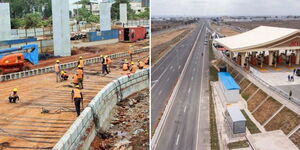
212, 45, 300, 106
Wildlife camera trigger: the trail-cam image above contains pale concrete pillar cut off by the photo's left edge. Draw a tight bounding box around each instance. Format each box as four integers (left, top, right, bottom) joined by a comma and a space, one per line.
0, 3, 11, 41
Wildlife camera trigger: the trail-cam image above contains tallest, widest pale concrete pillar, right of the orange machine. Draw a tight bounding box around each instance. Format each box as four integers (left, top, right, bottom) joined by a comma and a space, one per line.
52, 0, 71, 56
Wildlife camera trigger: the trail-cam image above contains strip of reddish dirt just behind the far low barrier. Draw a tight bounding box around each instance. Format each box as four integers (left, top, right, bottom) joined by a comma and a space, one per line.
31, 39, 149, 69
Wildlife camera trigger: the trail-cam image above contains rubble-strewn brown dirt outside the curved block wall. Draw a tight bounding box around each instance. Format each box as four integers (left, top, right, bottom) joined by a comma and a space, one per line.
90, 90, 149, 150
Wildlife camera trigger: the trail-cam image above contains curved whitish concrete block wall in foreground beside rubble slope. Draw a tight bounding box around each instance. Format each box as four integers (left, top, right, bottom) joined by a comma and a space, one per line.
53, 69, 149, 150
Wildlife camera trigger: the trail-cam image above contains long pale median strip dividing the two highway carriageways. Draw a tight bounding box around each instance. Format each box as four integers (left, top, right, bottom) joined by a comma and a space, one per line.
151, 25, 204, 150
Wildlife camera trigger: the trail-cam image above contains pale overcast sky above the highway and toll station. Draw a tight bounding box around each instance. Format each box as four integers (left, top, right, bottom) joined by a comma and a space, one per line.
151, 0, 300, 16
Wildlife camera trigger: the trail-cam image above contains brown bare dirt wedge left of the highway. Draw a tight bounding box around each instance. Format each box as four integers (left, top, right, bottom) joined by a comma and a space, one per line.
151, 25, 195, 64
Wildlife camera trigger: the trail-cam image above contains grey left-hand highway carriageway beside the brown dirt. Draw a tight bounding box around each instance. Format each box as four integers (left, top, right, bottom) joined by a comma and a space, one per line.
151, 24, 201, 129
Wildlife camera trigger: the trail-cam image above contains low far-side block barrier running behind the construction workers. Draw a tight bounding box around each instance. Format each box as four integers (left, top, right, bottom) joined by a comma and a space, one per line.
0, 47, 149, 82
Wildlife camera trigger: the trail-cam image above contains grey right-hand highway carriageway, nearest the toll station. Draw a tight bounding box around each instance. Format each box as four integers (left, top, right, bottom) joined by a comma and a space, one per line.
151, 20, 209, 150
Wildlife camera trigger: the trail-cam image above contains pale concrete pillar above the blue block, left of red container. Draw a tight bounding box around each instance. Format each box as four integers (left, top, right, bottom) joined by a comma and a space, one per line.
100, 2, 111, 31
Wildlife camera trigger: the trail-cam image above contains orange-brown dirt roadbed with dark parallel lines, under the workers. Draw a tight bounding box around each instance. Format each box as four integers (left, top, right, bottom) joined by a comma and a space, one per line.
0, 52, 148, 149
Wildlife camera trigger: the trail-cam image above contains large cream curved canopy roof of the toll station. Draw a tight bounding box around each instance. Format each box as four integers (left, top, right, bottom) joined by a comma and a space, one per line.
214, 26, 300, 52
